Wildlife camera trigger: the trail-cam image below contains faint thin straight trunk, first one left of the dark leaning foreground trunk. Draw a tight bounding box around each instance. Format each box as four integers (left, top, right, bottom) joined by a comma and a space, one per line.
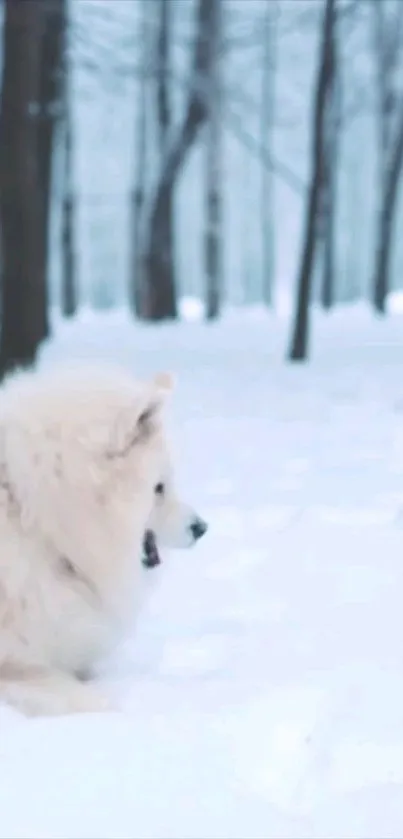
261, 0, 278, 308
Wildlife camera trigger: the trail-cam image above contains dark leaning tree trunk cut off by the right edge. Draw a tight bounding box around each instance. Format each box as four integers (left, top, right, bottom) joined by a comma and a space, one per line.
374, 102, 403, 315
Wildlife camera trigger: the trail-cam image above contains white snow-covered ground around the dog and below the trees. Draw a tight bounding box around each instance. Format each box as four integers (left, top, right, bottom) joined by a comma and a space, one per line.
0, 309, 403, 839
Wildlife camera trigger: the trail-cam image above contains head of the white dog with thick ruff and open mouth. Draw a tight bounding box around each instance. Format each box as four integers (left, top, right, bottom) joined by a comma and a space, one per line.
0, 366, 207, 568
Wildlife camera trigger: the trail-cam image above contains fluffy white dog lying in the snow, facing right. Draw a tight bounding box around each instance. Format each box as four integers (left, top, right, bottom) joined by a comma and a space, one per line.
0, 366, 207, 714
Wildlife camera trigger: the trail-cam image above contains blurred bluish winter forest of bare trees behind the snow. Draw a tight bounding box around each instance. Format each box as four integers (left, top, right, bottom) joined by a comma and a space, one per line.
0, 0, 403, 374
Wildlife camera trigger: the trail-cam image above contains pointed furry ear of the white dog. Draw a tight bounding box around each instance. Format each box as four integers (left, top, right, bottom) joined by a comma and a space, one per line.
108, 381, 169, 457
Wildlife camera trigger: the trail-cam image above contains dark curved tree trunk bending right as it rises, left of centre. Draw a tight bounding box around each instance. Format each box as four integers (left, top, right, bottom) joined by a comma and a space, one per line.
144, 0, 215, 320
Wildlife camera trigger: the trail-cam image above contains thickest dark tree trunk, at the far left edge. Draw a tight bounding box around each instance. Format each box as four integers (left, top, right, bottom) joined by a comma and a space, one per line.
0, 0, 48, 375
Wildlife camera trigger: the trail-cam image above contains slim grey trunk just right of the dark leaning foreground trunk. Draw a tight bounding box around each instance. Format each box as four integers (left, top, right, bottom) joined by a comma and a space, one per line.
321, 13, 341, 310
